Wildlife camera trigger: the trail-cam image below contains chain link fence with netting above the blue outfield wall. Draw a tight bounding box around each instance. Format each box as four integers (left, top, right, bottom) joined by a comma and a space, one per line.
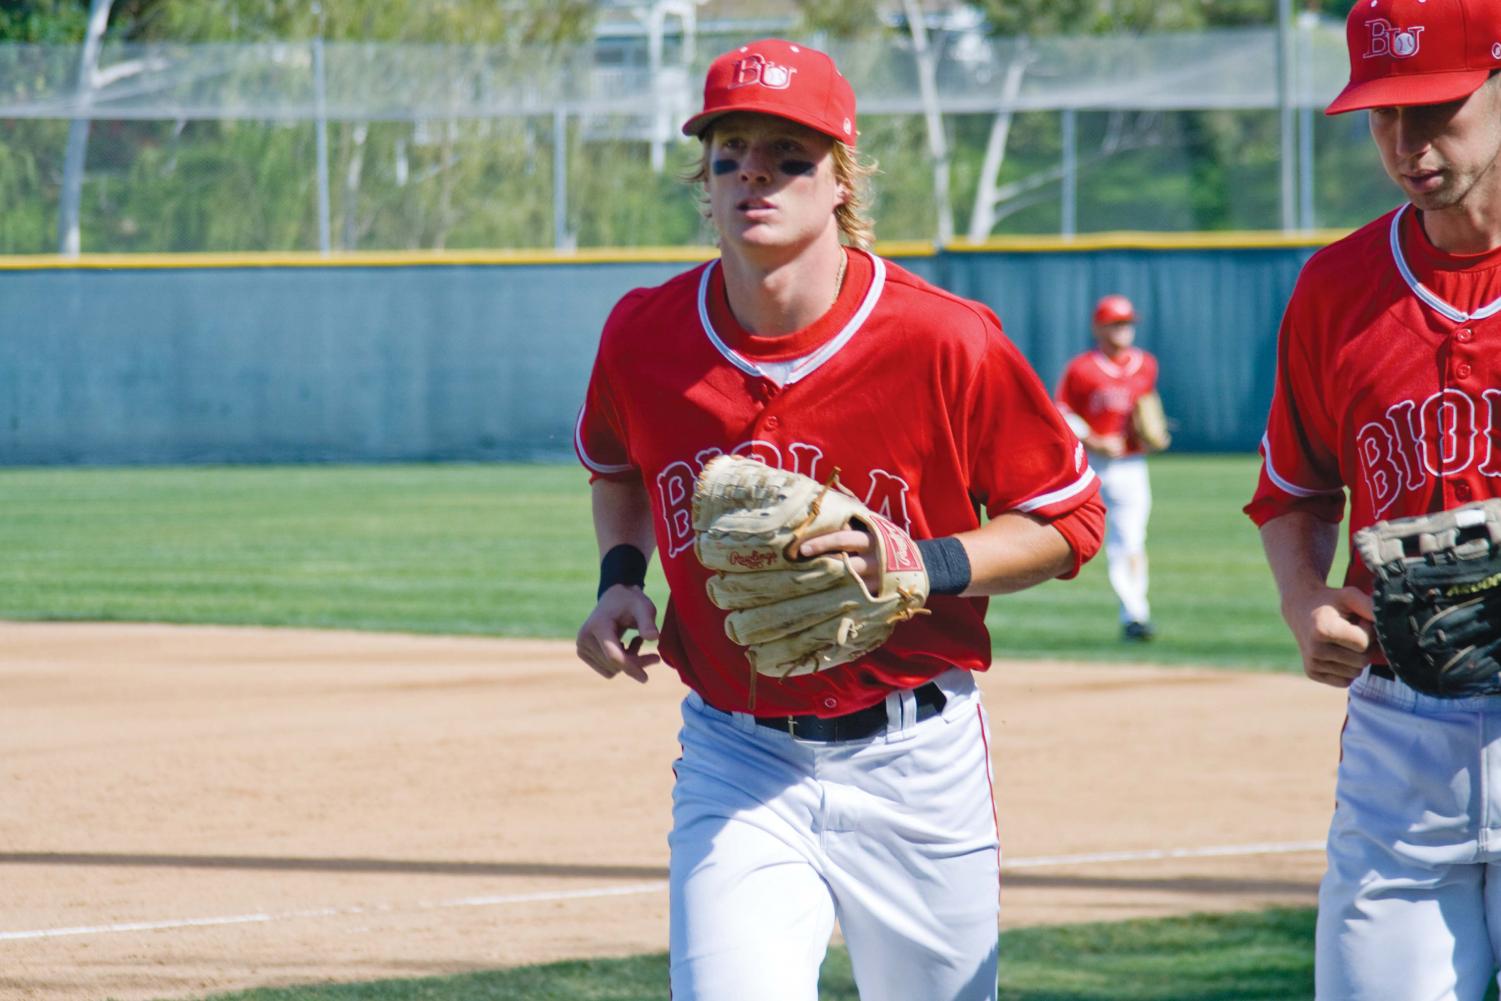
0, 21, 1397, 254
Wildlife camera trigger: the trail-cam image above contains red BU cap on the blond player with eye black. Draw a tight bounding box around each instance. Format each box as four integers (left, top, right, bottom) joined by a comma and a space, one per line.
683, 38, 859, 146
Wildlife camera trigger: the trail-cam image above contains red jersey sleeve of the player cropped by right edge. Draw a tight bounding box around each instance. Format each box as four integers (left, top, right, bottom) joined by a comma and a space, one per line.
1244, 279, 1345, 527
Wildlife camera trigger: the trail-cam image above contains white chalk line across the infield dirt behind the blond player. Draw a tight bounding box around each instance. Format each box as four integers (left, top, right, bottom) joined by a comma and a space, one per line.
0, 840, 1324, 942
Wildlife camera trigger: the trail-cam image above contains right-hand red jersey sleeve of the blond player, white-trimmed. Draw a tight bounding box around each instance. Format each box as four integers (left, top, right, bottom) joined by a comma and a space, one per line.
961, 318, 1099, 521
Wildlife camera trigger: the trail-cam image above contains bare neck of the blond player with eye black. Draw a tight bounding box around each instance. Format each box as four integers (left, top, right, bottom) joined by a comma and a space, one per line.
719, 236, 845, 338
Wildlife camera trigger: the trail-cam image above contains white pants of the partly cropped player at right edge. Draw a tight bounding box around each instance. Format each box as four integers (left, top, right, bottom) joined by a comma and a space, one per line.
1315, 674, 1501, 1001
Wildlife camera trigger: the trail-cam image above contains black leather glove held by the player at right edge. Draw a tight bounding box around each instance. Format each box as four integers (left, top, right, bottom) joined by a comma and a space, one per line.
1354, 500, 1501, 698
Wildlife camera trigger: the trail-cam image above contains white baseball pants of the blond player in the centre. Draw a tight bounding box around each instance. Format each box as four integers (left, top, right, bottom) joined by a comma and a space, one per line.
669, 671, 1000, 1001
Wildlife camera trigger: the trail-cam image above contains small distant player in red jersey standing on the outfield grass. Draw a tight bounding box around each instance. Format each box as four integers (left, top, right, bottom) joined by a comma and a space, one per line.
1057, 296, 1157, 641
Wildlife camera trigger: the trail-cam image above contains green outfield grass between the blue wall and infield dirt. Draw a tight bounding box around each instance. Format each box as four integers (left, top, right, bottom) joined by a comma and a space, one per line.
0, 456, 1326, 669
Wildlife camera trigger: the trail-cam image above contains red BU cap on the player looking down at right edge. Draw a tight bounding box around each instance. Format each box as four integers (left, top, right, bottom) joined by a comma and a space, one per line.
1324, 0, 1501, 114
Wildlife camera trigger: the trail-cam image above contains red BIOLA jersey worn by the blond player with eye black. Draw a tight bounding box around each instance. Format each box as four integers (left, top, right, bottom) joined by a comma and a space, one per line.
575, 249, 1103, 716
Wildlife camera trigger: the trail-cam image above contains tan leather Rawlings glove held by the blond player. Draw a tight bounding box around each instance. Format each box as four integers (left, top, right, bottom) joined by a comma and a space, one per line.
693, 456, 928, 680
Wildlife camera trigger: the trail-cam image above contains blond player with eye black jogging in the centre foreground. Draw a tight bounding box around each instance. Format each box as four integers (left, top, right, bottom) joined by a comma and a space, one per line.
576, 39, 1103, 1001
